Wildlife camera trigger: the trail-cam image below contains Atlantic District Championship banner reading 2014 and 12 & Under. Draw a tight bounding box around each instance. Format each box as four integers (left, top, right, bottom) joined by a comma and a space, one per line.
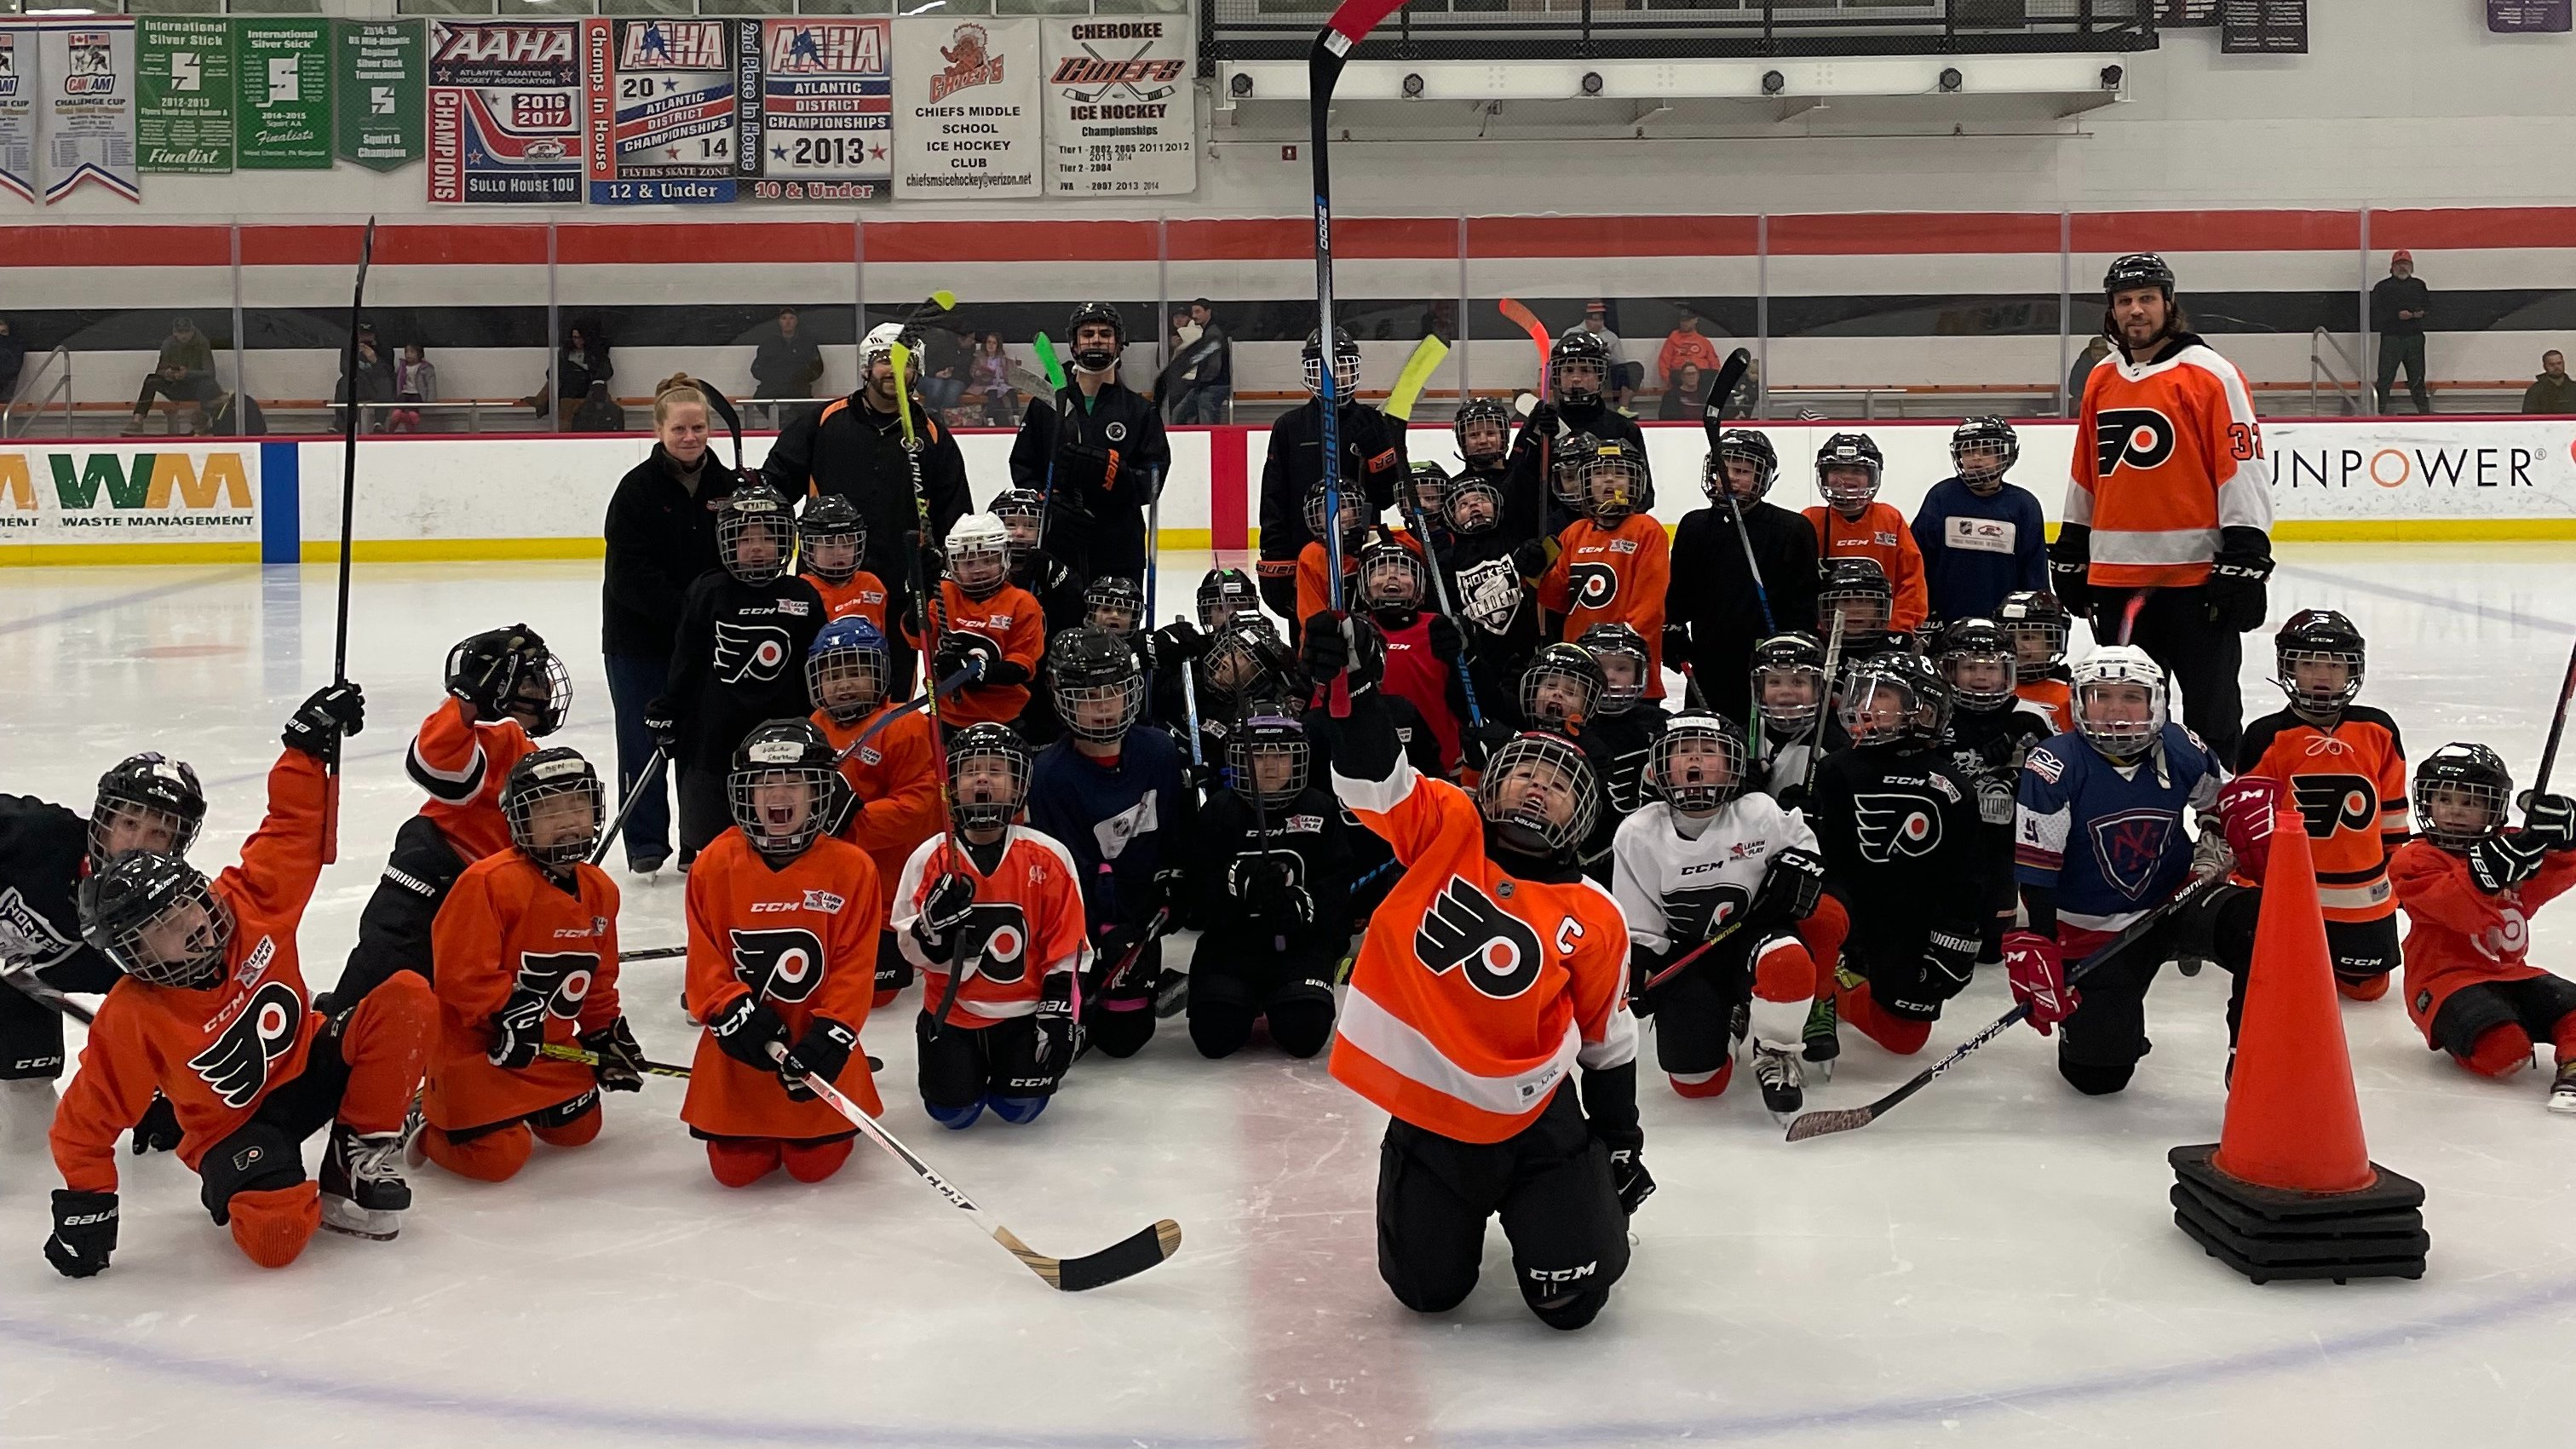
582, 18, 742, 206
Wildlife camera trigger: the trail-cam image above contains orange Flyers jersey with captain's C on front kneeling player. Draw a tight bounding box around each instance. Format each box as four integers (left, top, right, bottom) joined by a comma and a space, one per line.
1331, 756, 1636, 1142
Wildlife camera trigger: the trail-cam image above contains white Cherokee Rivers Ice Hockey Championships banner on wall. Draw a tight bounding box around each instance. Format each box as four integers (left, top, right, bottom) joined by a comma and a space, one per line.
1044, 15, 1198, 196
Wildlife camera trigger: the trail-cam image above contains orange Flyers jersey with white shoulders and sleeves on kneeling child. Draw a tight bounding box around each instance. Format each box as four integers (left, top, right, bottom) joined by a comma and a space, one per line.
891, 825, 1092, 1026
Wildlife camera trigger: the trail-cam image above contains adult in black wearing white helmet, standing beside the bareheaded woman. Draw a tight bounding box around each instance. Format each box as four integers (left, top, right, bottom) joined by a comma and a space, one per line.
760, 322, 974, 699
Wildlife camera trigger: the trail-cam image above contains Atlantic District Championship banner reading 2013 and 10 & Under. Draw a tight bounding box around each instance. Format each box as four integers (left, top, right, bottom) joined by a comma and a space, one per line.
734, 15, 894, 201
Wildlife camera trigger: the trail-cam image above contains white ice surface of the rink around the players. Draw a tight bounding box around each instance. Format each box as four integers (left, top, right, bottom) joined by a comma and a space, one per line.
0, 544, 2576, 1449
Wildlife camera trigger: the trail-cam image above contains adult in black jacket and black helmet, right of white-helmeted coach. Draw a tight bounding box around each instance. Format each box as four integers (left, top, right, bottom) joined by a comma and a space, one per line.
1009, 302, 1172, 583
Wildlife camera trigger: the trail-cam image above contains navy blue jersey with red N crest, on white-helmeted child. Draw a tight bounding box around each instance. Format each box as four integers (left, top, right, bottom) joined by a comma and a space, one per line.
2012, 725, 2228, 931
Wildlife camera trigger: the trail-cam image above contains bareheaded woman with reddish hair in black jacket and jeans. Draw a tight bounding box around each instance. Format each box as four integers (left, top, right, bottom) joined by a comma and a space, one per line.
601, 374, 739, 874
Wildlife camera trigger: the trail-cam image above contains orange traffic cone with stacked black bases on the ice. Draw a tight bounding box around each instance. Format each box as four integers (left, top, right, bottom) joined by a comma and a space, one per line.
2166, 802, 2432, 1284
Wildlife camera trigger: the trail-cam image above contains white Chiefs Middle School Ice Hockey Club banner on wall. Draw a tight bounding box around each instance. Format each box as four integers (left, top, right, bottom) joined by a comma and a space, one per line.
894, 18, 1041, 198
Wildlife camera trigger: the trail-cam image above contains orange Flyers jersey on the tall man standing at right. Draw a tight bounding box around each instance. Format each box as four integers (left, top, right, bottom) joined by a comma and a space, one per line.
2066, 335, 2272, 588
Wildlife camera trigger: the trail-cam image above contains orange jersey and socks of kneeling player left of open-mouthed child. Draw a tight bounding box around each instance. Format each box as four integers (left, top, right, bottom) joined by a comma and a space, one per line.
420, 851, 618, 1132
